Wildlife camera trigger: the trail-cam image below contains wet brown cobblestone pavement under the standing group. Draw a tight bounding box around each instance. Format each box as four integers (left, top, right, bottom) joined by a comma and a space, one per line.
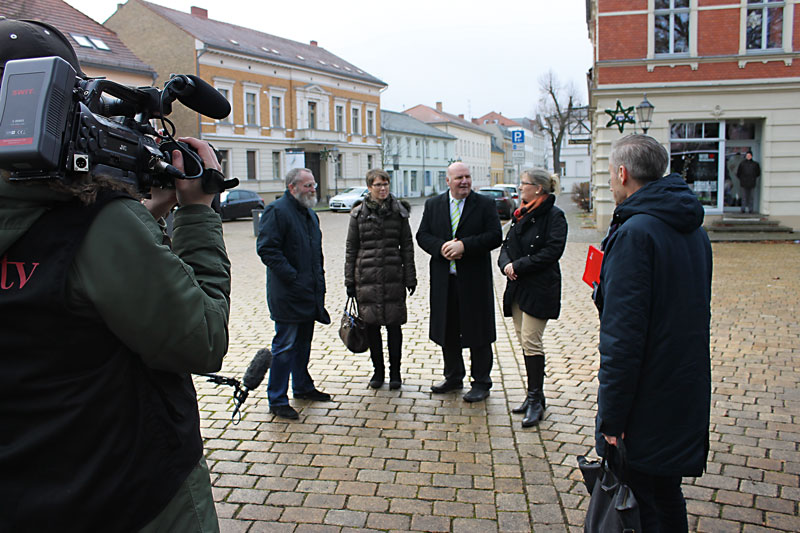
196, 197, 800, 533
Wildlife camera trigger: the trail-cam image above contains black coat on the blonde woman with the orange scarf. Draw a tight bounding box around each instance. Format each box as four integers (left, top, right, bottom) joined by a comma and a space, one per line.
497, 194, 567, 318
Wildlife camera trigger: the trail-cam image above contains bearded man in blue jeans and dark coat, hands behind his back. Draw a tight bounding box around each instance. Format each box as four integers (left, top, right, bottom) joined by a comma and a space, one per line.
256, 168, 331, 420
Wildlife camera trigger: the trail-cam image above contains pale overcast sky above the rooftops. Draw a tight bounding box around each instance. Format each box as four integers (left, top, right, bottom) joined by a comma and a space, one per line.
67, 0, 592, 118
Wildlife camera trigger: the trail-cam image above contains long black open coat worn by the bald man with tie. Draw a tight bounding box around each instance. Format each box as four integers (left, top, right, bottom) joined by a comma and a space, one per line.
417, 192, 503, 347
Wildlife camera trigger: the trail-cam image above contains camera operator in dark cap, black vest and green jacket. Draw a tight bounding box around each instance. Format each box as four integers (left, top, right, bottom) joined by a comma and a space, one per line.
0, 18, 230, 533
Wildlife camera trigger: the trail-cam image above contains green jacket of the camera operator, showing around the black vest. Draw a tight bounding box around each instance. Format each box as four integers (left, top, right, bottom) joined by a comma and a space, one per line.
0, 178, 231, 373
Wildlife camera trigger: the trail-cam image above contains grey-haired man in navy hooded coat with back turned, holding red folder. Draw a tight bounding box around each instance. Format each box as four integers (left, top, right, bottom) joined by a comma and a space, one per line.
595, 135, 712, 532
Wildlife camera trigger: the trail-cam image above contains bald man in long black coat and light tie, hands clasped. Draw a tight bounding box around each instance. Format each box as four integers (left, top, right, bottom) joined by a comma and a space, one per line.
417, 162, 503, 402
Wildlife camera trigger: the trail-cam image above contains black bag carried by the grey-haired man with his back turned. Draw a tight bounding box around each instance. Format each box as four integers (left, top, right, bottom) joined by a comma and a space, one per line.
578, 438, 642, 533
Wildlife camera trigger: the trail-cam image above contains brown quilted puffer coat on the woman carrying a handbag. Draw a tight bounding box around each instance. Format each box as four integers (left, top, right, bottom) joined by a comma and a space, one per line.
344, 195, 417, 326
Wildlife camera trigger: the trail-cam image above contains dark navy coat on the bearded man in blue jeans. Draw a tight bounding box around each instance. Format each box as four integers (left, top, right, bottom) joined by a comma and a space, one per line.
256, 189, 331, 324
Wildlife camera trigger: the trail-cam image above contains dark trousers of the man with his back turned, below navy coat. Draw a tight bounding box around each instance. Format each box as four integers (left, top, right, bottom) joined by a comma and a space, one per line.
625, 468, 689, 533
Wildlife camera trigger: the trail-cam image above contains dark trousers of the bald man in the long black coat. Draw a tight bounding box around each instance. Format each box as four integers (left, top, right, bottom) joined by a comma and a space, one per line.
442, 275, 492, 390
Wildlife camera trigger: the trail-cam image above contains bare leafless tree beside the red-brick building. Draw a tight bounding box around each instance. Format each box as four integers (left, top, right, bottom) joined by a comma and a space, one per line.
537, 70, 580, 176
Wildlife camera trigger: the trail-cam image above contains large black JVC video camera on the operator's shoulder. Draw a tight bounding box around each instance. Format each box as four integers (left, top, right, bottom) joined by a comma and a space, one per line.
0, 56, 239, 194
